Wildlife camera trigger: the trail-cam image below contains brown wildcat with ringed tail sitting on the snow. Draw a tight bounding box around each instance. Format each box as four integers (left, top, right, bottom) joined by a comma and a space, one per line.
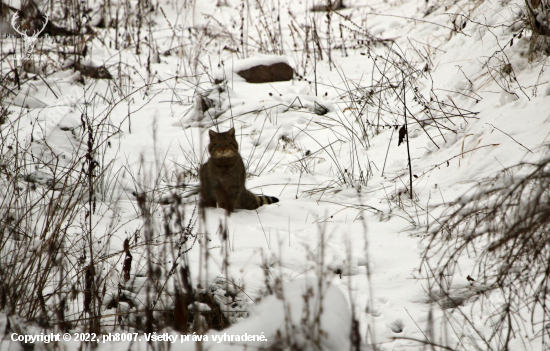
199, 128, 279, 214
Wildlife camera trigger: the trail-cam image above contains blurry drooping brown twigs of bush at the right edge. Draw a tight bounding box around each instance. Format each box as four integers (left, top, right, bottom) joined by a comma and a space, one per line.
423, 150, 550, 350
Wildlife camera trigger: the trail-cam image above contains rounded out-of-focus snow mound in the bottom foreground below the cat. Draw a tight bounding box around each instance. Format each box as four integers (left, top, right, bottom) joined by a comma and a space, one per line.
189, 278, 351, 350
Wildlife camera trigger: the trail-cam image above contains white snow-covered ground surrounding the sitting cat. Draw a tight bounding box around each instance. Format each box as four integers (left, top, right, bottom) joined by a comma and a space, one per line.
0, 0, 550, 350
